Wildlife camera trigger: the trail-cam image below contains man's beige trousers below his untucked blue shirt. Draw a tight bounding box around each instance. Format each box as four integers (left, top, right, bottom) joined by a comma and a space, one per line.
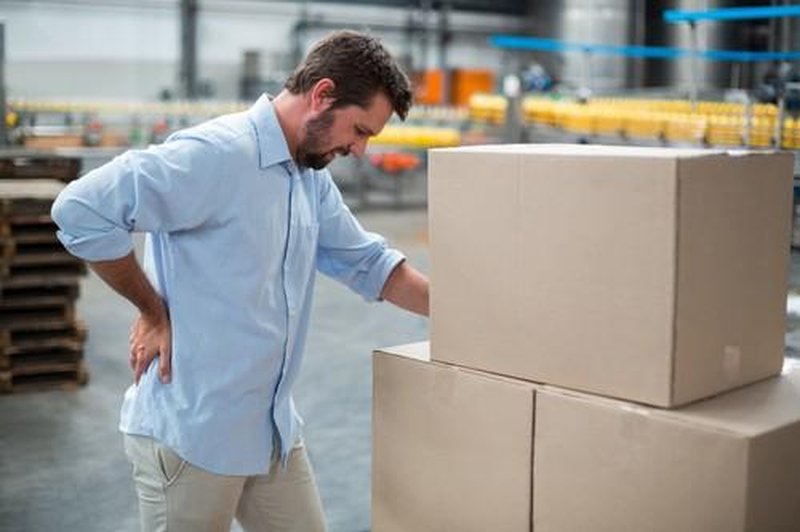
125, 435, 326, 532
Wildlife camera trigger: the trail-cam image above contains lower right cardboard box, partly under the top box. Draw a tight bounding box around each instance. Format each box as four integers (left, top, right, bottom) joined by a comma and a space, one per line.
533, 360, 800, 532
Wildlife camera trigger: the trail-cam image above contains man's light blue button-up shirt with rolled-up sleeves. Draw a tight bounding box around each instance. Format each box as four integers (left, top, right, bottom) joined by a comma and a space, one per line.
52, 96, 403, 475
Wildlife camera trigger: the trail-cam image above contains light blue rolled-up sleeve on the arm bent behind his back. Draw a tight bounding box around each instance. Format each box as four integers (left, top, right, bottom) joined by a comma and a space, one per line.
51, 137, 222, 261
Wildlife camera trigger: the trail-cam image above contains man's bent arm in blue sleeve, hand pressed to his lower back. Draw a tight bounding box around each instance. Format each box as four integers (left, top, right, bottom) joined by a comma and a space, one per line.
52, 138, 227, 382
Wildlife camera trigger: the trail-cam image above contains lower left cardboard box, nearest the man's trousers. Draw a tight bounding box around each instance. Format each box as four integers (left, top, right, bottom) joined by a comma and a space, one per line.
372, 343, 534, 532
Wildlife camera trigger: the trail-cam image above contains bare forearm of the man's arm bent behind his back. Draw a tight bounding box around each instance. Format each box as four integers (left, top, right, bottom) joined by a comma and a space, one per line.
89, 252, 167, 321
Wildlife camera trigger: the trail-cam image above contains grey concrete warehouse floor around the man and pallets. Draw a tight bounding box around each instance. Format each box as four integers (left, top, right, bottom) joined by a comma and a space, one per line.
0, 211, 800, 532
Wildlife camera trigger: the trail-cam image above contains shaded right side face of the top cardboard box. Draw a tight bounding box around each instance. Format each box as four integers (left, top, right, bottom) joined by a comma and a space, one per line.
673, 154, 792, 403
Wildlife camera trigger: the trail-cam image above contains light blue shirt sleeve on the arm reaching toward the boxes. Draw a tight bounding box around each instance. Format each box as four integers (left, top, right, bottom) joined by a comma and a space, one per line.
317, 172, 405, 301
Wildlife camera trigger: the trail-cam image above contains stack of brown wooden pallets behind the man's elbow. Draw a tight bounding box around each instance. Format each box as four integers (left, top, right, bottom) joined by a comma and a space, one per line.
0, 179, 88, 393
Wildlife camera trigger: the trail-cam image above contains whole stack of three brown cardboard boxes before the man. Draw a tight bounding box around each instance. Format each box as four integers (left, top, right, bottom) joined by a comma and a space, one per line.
373, 145, 800, 532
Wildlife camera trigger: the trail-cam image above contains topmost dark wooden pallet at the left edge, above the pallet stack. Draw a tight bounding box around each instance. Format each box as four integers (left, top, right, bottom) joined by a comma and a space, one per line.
0, 153, 81, 183
